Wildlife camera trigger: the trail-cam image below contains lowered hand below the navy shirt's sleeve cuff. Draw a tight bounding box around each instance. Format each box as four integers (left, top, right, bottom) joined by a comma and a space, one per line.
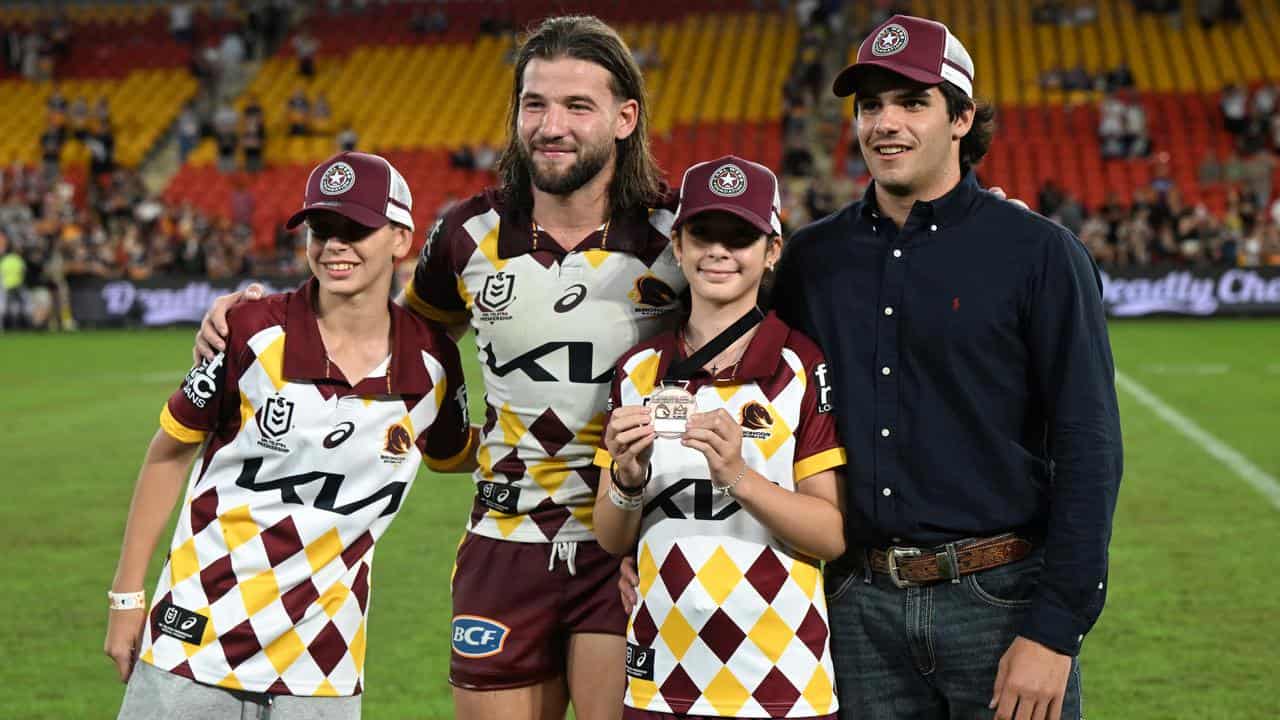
988, 637, 1071, 720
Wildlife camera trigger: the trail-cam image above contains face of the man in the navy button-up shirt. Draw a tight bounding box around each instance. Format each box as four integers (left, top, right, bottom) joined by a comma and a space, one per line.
855, 70, 973, 200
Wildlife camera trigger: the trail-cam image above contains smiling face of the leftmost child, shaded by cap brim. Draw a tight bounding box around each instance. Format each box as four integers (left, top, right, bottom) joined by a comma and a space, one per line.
306, 210, 412, 296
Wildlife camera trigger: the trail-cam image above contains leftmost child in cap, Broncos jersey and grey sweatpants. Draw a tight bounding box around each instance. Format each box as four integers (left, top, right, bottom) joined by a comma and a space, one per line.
105, 152, 475, 720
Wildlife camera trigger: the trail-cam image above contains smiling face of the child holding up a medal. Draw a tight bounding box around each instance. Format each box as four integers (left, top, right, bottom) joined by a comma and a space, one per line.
672, 210, 782, 306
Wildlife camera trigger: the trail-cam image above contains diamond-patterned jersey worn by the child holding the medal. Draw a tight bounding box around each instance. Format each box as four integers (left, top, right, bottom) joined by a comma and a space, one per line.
596, 314, 845, 717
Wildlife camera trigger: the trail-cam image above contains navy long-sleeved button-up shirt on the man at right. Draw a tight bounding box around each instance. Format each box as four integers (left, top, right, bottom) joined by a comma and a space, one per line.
773, 173, 1121, 655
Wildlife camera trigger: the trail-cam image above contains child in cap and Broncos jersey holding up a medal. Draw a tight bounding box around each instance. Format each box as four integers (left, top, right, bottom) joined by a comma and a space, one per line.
595, 156, 845, 719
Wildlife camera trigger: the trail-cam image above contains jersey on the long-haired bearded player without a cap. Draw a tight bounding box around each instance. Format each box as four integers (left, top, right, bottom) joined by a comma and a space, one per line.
406, 191, 687, 543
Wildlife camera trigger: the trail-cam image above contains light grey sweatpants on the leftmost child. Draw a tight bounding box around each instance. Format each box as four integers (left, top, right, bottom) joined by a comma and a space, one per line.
118, 661, 361, 720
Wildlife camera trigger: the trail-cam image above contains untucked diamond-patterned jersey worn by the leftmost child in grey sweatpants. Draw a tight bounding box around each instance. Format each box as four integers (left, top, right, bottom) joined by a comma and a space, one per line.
141, 281, 475, 696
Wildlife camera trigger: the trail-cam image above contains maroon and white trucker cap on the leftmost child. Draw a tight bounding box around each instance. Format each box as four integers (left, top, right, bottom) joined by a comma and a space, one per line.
284, 152, 413, 229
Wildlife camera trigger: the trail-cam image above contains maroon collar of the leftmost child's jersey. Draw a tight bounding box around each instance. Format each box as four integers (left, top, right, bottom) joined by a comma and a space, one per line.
284, 278, 431, 395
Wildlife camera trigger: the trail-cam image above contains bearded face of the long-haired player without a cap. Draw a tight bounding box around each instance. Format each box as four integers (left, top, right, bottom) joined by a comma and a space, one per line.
516, 58, 639, 196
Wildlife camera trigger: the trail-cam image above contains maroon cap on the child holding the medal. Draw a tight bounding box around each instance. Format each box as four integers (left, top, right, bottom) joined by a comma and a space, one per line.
672, 155, 782, 234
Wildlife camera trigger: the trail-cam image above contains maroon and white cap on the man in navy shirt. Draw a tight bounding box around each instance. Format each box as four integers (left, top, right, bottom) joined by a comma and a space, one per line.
831, 15, 973, 97
